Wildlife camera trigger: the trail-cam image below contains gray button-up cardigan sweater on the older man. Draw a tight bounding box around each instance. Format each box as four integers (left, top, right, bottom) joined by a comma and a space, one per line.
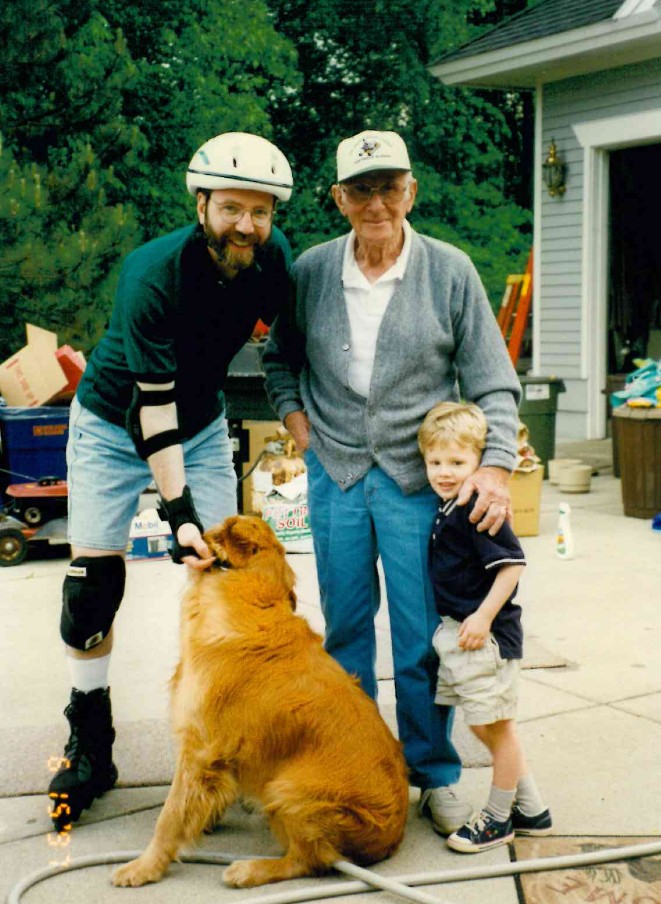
262, 226, 521, 494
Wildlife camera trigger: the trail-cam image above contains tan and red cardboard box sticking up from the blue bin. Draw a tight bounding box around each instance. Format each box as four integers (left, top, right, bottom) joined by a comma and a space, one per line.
0, 323, 85, 408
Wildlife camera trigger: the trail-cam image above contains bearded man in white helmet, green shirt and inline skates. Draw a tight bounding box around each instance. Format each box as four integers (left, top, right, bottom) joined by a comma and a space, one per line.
49, 132, 292, 831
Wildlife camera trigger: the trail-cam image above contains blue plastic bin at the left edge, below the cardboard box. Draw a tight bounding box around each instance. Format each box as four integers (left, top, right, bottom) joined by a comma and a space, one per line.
0, 405, 69, 494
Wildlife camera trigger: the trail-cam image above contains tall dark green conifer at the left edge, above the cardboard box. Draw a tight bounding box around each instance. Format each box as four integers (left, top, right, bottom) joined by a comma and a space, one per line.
0, 0, 140, 358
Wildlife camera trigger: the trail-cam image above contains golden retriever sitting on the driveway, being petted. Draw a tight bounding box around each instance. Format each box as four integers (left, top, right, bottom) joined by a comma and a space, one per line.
113, 516, 409, 887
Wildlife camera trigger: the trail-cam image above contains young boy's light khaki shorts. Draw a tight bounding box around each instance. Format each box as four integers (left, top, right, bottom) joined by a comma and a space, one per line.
433, 615, 521, 725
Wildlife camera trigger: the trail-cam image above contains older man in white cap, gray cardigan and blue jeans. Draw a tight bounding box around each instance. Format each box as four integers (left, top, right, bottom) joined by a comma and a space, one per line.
263, 131, 520, 835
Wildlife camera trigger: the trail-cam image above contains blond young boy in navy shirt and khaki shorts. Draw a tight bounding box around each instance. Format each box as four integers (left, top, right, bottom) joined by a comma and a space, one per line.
418, 402, 551, 853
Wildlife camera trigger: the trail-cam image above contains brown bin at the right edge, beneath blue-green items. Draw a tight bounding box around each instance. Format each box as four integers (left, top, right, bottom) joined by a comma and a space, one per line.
613, 405, 661, 518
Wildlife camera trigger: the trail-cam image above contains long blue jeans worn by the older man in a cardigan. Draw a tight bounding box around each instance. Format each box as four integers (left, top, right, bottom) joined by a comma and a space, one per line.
305, 450, 461, 789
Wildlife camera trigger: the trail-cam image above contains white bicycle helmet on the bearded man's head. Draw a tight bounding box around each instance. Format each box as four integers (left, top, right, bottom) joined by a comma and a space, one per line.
186, 132, 293, 201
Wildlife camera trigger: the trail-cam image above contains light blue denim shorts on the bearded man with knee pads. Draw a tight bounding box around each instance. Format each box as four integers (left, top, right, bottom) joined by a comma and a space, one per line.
67, 399, 237, 551
